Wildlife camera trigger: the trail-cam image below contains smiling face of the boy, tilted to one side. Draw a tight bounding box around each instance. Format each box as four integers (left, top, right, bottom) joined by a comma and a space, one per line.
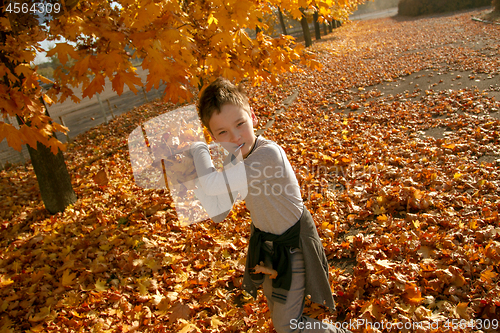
208, 104, 257, 157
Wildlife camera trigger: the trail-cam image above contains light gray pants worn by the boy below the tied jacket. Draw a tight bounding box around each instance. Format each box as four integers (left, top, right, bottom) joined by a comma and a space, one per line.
263, 244, 350, 333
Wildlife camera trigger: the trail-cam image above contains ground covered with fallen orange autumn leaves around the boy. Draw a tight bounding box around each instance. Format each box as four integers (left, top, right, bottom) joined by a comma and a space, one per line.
0, 7, 500, 333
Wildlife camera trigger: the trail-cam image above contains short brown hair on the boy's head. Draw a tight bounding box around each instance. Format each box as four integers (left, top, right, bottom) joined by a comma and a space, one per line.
198, 77, 250, 131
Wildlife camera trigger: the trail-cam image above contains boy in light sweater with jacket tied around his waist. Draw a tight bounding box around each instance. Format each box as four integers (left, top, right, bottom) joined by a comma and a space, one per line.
190, 78, 344, 333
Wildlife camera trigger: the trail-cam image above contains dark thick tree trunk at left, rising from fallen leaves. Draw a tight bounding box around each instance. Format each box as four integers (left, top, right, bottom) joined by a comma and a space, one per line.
28, 142, 76, 214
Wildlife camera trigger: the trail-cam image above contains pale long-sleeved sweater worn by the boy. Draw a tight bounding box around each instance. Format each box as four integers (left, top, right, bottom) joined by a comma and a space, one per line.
191, 136, 303, 235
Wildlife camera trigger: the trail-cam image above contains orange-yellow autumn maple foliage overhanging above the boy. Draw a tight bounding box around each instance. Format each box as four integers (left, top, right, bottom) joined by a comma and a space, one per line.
0, 0, 364, 153
